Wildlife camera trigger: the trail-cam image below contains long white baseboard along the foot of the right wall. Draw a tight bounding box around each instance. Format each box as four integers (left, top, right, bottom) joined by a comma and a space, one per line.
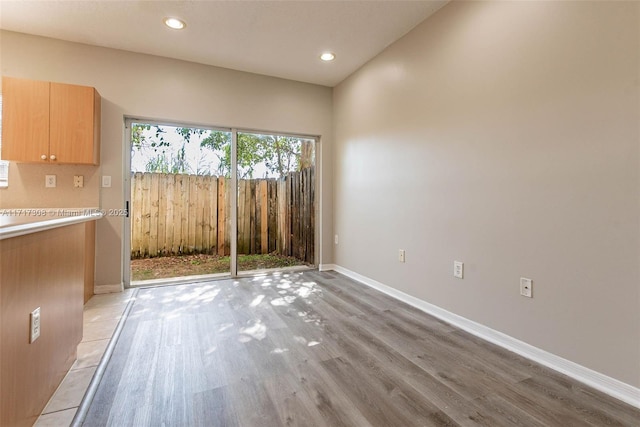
319, 264, 640, 408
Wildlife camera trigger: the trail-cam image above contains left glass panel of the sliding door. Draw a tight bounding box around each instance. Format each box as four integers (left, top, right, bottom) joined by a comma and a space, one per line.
130, 123, 234, 285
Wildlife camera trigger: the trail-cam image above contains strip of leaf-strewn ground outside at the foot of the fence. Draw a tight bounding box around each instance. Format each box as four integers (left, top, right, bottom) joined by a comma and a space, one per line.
131, 254, 306, 280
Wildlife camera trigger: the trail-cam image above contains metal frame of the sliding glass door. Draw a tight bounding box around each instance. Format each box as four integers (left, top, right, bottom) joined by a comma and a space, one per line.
122, 116, 322, 288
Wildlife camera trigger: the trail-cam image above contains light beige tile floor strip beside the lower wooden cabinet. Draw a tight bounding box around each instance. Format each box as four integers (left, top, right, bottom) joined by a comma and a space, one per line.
35, 289, 134, 427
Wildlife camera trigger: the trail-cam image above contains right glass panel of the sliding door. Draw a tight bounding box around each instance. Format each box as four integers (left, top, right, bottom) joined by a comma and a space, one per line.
237, 132, 315, 274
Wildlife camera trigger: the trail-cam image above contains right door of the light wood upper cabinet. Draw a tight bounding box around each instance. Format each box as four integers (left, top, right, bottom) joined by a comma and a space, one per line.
49, 83, 99, 164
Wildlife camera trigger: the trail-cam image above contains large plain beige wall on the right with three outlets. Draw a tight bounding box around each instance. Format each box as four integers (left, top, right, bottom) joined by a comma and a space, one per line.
334, 2, 640, 387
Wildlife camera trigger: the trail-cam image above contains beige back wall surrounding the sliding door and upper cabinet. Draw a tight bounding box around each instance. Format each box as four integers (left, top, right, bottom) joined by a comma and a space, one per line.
0, 31, 333, 286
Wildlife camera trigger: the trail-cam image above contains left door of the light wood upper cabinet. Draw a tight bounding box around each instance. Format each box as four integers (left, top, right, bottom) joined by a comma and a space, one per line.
1, 77, 49, 162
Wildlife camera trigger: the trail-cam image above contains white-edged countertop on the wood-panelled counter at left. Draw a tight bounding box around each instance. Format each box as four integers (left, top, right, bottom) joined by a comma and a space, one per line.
0, 208, 104, 240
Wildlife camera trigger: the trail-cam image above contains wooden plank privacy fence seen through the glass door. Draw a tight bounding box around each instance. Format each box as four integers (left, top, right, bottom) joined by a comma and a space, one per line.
131, 167, 315, 264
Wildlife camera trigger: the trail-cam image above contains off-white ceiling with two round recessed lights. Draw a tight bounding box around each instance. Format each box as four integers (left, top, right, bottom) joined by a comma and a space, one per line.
0, 0, 448, 86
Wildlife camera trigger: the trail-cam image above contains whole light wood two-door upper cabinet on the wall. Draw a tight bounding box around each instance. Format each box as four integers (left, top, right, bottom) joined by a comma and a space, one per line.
1, 77, 101, 165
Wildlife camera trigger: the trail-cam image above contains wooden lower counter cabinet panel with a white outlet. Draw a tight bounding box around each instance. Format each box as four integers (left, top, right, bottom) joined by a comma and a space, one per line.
0, 221, 95, 427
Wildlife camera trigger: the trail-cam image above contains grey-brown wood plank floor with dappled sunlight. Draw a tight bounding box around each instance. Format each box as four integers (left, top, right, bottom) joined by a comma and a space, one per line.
80, 271, 640, 427
